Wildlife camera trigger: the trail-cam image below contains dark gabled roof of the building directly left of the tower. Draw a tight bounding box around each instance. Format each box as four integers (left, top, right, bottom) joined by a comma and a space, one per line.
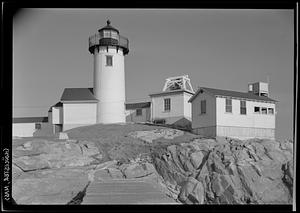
60, 88, 98, 102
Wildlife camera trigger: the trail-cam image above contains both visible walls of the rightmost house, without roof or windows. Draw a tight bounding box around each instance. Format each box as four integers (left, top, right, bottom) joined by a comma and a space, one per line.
192, 93, 276, 139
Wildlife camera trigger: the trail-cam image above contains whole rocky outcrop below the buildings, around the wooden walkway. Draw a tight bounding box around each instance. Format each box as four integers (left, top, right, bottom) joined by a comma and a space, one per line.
12, 125, 294, 204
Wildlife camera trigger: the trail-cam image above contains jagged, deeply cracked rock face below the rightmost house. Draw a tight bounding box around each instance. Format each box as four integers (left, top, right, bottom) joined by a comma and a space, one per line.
152, 138, 293, 204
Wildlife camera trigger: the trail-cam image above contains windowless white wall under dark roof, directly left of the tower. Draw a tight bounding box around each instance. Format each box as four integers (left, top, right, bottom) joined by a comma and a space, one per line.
63, 103, 97, 125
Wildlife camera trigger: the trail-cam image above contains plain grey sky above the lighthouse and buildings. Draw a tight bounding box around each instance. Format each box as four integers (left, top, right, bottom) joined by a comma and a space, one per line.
13, 8, 294, 139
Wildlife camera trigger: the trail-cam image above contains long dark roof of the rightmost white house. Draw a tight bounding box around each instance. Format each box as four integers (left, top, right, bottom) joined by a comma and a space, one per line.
189, 87, 278, 102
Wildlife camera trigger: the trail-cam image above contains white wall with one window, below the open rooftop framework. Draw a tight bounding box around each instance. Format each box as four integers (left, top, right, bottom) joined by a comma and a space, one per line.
151, 93, 184, 123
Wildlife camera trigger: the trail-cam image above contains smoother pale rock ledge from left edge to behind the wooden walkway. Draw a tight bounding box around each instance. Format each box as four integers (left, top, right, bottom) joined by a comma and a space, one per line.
12, 139, 176, 205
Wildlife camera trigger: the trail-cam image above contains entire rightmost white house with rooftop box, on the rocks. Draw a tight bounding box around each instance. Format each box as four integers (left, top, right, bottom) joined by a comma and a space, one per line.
189, 82, 277, 140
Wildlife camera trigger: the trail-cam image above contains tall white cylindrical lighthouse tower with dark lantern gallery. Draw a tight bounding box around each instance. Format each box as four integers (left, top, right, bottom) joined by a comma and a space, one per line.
89, 20, 129, 124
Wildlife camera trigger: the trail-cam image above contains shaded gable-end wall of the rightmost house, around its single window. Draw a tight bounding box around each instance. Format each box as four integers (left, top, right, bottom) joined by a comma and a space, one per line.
192, 93, 216, 129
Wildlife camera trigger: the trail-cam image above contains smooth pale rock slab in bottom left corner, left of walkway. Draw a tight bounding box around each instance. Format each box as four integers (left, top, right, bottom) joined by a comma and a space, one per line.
12, 168, 88, 205
